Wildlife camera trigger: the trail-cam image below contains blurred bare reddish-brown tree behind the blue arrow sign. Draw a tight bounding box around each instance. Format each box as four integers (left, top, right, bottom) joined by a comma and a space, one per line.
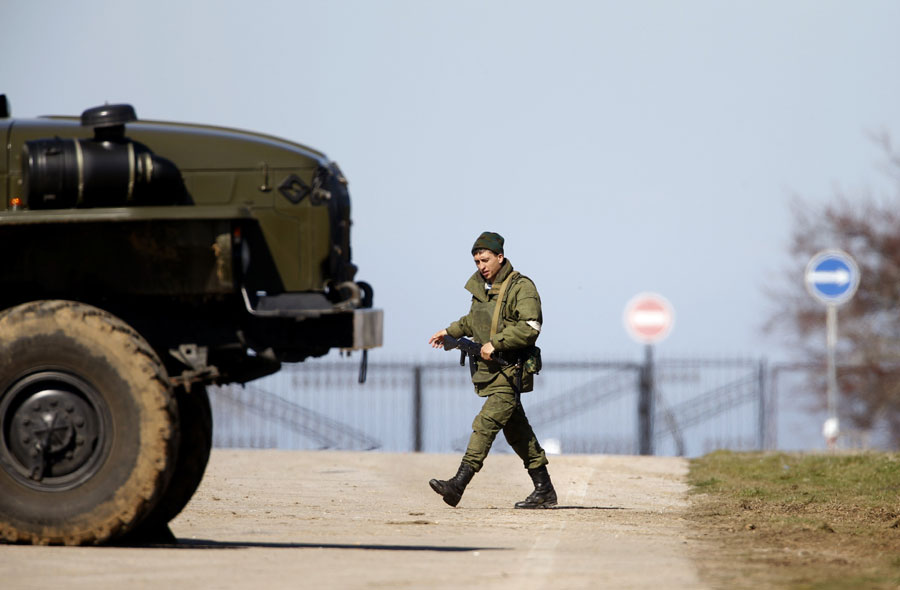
768, 136, 900, 448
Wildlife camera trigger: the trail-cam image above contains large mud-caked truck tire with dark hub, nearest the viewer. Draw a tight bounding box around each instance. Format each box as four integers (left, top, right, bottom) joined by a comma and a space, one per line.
0, 301, 178, 545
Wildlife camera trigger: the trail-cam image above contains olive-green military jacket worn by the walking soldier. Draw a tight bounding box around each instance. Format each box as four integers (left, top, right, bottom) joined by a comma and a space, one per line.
447, 258, 543, 395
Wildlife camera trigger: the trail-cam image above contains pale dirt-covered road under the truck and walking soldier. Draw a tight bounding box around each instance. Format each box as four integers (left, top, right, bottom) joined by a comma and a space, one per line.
0, 450, 703, 590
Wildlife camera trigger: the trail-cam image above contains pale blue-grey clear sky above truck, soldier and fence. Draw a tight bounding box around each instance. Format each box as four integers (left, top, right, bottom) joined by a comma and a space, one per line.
0, 0, 900, 361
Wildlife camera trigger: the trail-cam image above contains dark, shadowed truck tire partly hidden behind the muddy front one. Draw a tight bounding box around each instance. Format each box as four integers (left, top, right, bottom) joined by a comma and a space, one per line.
124, 383, 212, 545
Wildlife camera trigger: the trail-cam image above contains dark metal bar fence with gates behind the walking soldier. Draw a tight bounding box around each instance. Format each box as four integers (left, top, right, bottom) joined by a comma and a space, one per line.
210, 359, 773, 456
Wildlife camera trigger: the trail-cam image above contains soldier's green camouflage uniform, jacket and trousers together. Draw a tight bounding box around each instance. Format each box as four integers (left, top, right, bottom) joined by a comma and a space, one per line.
447, 259, 547, 471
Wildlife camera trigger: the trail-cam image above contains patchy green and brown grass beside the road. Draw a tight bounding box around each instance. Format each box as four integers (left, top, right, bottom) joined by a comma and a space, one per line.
688, 451, 900, 590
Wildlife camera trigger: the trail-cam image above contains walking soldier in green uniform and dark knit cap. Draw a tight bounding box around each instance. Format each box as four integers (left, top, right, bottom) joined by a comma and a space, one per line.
428, 232, 556, 508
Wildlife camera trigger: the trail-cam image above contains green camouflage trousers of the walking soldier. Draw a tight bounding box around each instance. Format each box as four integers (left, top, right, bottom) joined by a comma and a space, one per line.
462, 377, 548, 471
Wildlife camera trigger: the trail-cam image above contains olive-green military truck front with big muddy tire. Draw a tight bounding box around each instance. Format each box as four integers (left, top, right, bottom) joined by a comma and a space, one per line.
0, 95, 382, 545
